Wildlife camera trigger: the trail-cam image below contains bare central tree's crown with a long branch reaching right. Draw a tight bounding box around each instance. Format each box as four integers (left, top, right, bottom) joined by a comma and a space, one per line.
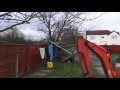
37, 12, 106, 42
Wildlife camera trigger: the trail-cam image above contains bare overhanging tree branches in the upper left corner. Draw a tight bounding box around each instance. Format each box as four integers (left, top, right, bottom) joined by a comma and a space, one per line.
0, 12, 36, 32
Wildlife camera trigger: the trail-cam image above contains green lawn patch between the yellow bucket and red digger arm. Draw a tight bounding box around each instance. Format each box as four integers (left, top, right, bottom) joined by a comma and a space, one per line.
46, 61, 82, 78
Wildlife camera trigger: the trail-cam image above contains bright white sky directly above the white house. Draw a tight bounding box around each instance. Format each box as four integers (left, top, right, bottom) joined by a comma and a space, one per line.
90, 12, 120, 32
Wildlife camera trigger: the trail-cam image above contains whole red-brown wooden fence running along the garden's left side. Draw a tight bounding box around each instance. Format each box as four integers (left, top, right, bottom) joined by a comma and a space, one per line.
0, 45, 47, 78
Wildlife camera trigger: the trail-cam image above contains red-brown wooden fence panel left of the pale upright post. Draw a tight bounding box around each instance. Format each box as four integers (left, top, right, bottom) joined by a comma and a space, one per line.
0, 45, 16, 78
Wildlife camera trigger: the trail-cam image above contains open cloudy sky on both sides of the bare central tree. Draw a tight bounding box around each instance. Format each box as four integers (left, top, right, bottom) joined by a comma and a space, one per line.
17, 12, 120, 40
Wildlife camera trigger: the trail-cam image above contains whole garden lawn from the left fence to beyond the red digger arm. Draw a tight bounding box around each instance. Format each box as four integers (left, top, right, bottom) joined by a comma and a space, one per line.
21, 53, 120, 78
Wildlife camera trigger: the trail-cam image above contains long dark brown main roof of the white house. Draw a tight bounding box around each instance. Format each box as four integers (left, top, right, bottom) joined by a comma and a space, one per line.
86, 30, 111, 35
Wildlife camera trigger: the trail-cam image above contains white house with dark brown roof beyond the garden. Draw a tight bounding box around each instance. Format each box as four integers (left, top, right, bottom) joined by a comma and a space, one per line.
86, 30, 120, 45
